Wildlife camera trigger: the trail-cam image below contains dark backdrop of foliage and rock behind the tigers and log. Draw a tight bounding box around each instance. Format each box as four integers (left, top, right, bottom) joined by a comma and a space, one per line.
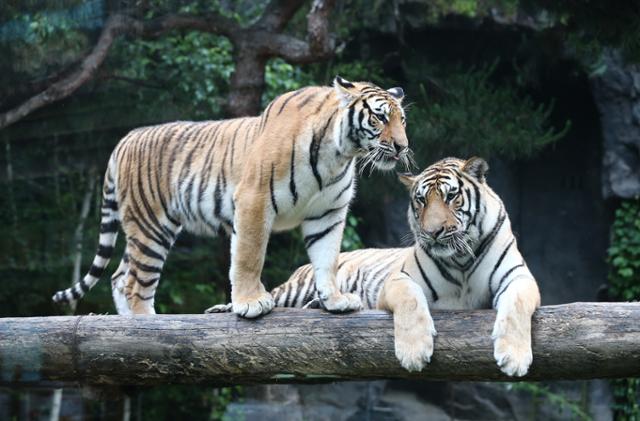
0, 0, 640, 420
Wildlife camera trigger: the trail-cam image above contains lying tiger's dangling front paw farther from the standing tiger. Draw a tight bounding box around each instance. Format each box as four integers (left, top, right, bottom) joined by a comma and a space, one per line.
492, 329, 533, 377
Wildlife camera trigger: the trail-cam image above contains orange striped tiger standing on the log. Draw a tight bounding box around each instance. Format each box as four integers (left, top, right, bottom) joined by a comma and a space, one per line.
53, 76, 409, 318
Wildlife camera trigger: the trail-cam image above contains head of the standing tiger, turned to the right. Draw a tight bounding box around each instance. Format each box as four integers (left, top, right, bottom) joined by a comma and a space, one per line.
333, 76, 412, 170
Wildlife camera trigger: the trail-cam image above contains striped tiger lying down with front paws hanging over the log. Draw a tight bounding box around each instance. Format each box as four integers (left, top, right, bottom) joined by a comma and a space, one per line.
208, 158, 540, 376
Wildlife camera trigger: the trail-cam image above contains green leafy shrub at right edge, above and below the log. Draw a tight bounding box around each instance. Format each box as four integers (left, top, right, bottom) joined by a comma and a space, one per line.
608, 199, 640, 421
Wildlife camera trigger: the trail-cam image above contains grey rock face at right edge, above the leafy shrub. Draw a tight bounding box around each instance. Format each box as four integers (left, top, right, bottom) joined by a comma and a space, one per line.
591, 51, 640, 198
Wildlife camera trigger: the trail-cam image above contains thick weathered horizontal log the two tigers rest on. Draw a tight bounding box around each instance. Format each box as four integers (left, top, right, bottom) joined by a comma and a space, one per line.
0, 303, 640, 385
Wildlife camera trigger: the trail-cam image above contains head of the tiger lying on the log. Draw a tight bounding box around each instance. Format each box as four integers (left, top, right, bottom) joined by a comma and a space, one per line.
399, 157, 489, 258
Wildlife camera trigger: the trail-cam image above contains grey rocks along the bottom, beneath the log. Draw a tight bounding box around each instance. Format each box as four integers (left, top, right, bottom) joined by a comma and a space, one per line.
225, 380, 612, 421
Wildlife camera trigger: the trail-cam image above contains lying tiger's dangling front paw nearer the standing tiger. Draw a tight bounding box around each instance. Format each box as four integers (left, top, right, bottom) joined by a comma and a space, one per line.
394, 312, 437, 371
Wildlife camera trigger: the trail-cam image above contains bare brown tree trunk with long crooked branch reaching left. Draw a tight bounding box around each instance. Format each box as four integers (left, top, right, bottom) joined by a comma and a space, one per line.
0, 0, 335, 129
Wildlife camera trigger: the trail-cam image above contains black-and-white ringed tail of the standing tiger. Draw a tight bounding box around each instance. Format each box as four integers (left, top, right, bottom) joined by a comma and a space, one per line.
52, 158, 119, 303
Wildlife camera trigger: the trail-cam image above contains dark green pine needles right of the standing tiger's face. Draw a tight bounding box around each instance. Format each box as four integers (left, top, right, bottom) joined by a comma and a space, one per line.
407, 62, 570, 164
